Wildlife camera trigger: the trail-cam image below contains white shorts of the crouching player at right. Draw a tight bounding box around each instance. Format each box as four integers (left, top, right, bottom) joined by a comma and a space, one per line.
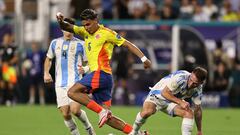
144, 94, 177, 116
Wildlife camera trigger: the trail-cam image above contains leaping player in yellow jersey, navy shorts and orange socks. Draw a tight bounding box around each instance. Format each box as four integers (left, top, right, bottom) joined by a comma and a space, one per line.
56, 9, 151, 135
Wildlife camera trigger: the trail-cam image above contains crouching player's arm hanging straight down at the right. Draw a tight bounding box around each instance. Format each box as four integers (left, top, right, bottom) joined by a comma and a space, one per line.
194, 105, 202, 135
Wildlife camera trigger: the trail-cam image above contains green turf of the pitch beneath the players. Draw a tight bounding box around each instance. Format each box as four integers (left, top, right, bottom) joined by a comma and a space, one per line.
0, 105, 240, 135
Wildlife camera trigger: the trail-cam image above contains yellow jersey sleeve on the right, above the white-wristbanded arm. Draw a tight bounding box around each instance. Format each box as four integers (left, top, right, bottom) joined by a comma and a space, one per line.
106, 30, 126, 46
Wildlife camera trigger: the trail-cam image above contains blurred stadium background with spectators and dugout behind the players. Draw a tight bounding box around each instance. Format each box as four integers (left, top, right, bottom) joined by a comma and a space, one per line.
0, 0, 240, 108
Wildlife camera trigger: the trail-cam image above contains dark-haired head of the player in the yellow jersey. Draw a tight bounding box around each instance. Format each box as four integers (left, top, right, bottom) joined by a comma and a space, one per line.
80, 9, 98, 34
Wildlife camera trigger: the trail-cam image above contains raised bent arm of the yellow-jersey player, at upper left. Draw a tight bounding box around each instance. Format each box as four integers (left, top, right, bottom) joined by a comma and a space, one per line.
56, 12, 74, 33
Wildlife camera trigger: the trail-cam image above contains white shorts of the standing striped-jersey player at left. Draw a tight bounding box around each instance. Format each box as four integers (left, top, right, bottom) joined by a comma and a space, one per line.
55, 87, 75, 108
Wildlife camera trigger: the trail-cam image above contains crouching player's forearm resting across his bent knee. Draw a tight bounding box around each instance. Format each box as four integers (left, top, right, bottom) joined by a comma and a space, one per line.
162, 86, 190, 110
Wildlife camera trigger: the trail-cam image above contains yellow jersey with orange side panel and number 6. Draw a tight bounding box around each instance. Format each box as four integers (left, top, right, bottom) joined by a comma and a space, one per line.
73, 25, 125, 74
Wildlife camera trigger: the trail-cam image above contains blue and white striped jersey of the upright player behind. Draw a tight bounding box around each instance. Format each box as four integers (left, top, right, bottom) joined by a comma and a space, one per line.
47, 37, 87, 87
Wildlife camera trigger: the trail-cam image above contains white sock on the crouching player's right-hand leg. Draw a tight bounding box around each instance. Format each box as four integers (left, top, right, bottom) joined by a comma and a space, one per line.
182, 118, 194, 135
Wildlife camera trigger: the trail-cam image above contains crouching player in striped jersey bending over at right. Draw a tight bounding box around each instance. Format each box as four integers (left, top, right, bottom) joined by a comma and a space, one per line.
130, 67, 207, 135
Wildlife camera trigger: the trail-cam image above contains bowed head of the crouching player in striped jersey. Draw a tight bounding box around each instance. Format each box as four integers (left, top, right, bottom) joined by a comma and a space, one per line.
188, 67, 207, 89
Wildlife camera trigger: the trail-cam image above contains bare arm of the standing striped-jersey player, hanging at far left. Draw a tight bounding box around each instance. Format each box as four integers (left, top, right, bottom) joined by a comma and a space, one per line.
43, 57, 53, 83
